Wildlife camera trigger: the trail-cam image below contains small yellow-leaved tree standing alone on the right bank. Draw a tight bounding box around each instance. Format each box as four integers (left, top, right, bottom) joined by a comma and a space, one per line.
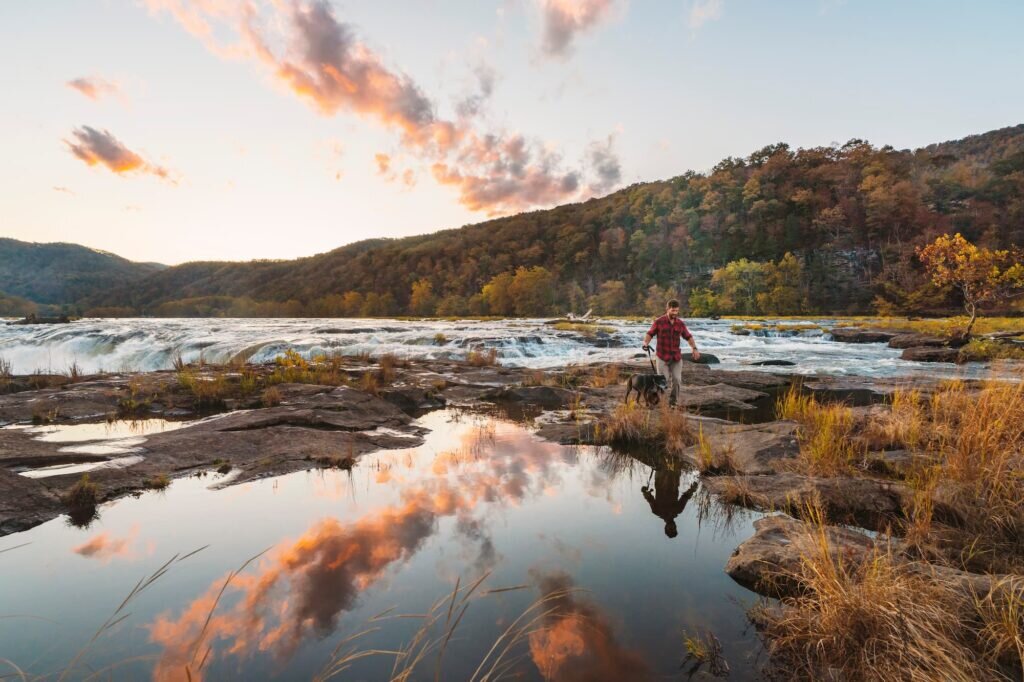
918, 232, 1024, 338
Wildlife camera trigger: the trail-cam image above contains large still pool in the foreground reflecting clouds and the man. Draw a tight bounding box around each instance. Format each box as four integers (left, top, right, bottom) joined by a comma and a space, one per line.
0, 411, 763, 680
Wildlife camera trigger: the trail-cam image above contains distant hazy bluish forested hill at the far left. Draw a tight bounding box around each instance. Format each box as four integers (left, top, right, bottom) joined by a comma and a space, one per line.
0, 239, 165, 304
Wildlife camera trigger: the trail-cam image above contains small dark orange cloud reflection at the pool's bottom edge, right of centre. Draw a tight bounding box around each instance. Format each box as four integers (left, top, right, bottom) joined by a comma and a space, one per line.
529, 572, 650, 682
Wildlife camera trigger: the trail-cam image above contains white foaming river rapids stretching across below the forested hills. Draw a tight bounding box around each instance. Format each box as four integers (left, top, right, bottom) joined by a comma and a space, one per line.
0, 318, 1007, 378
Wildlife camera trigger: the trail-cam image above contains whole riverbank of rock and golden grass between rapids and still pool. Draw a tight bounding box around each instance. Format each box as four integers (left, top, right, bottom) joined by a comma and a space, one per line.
0, 352, 1024, 677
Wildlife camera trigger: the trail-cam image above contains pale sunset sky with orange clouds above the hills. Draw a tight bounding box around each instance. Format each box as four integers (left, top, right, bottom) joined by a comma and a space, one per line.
0, 0, 1024, 264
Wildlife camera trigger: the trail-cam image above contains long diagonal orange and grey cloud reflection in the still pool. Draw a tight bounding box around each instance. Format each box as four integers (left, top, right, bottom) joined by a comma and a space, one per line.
151, 419, 589, 680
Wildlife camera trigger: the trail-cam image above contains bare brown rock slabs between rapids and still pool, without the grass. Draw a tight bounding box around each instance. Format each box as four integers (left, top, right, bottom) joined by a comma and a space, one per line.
0, 350, 1019, 675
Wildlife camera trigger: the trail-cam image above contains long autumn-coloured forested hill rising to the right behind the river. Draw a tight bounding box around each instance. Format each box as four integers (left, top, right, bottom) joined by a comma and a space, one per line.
79, 125, 1024, 315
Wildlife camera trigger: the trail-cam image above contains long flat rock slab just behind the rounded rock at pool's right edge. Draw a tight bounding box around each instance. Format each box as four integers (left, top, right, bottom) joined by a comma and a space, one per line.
707, 472, 911, 528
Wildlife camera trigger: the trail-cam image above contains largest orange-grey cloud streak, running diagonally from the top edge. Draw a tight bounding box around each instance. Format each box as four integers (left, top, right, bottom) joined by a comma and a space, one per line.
147, 0, 618, 215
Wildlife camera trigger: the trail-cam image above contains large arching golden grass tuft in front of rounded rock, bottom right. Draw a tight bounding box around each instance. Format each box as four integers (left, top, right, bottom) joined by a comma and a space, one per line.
755, 512, 990, 682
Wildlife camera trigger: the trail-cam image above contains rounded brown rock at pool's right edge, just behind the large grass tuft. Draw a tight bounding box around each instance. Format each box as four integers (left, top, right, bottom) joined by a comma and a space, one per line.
725, 514, 874, 597
